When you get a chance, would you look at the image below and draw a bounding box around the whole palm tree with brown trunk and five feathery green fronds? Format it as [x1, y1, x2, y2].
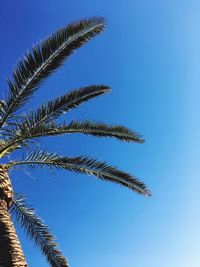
[0, 17, 150, 267]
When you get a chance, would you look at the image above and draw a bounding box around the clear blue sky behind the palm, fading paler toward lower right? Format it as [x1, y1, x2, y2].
[0, 0, 200, 267]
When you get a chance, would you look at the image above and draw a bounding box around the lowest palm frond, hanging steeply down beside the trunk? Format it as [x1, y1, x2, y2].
[11, 194, 69, 267]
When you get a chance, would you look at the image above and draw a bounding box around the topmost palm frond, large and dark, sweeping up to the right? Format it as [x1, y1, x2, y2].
[0, 17, 105, 128]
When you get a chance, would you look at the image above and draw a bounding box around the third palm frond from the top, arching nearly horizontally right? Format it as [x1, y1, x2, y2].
[0, 113, 144, 158]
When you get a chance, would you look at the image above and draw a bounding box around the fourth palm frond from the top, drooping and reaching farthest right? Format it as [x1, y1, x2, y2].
[7, 151, 151, 196]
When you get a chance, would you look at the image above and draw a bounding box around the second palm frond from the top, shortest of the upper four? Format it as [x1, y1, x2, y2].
[0, 85, 110, 158]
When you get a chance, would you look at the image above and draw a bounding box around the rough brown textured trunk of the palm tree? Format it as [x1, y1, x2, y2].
[0, 165, 28, 267]
